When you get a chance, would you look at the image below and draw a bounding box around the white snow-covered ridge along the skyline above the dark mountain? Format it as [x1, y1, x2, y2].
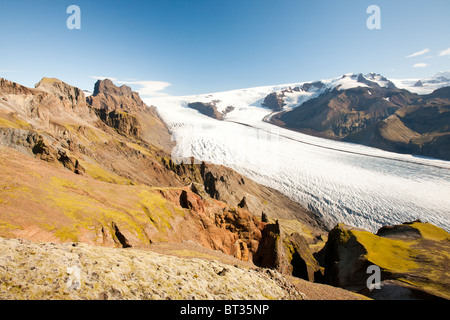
[147, 71, 450, 119]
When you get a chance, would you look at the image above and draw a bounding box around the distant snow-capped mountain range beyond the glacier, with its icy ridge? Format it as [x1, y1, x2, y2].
[180, 72, 450, 160]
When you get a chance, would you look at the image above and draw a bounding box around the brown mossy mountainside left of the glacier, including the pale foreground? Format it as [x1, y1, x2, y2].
[0, 78, 447, 299]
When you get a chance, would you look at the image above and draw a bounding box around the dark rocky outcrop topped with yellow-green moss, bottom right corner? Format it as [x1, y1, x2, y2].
[322, 221, 450, 299]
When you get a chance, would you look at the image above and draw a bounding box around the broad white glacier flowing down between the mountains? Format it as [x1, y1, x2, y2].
[144, 75, 450, 232]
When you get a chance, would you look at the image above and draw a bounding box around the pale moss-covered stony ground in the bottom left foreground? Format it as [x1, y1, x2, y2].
[0, 238, 304, 300]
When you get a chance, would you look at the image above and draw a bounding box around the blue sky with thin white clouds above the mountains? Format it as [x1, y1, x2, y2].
[0, 0, 450, 96]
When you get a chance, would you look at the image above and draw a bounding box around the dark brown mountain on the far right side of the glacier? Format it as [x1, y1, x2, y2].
[270, 74, 450, 160]
